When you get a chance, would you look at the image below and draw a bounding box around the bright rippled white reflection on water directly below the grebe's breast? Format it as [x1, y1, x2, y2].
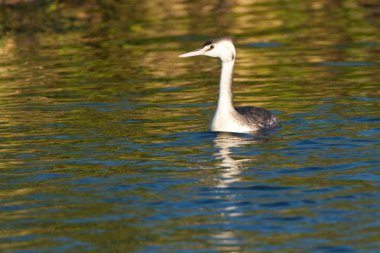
[214, 133, 259, 188]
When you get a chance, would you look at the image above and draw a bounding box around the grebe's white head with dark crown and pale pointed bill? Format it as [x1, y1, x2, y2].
[179, 38, 236, 62]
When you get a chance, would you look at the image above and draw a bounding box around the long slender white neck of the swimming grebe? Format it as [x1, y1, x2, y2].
[216, 60, 235, 114]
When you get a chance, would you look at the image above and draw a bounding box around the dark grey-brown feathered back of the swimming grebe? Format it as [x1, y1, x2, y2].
[235, 106, 280, 129]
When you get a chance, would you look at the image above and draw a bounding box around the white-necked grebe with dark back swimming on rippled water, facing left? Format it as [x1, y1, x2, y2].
[179, 37, 280, 133]
